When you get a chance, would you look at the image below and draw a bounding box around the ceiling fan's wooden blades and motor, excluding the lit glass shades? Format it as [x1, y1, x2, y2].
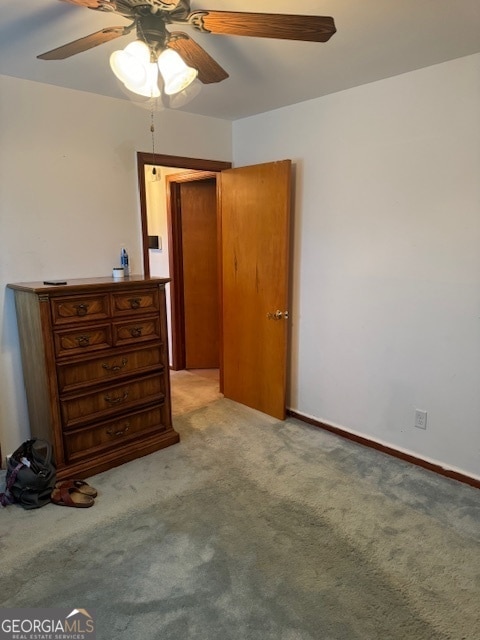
[37, 0, 336, 95]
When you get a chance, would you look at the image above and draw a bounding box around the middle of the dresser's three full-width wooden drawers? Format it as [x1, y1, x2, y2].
[60, 373, 165, 428]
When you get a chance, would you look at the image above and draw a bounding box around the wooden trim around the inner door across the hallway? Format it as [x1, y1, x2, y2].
[165, 171, 221, 371]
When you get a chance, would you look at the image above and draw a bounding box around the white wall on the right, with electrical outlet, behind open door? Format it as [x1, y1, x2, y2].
[233, 55, 480, 478]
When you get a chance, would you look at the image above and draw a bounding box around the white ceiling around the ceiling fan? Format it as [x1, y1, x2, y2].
[0, 0, 480, 120]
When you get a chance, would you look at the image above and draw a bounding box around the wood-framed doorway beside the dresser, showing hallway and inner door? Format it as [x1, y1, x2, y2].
[137, 152, 231, 379]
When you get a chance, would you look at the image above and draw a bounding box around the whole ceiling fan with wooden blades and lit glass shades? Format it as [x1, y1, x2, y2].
[37, 0, 336, 108]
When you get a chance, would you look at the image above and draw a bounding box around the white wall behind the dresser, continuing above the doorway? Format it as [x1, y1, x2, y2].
[0, 76, 232, 455]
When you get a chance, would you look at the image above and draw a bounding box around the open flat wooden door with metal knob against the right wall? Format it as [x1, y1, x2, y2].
[219, 160, 291, 420]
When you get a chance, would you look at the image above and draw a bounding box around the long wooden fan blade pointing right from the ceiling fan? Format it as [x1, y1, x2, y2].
[188, 10, 336, 42]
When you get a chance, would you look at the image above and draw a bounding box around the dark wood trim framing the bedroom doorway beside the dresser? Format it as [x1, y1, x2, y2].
[137, 151, 232, 278]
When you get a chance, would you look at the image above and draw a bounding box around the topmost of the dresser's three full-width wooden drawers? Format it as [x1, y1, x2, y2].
[57, 344, 164, 393]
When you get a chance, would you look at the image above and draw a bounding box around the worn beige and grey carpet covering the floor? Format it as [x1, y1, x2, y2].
[0, 372, 480, 640]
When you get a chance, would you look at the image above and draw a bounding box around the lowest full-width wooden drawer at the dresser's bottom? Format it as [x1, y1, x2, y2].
[64, 406, 166, 462]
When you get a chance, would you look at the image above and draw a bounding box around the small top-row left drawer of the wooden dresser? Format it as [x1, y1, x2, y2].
[50, 294, 110, 325]
